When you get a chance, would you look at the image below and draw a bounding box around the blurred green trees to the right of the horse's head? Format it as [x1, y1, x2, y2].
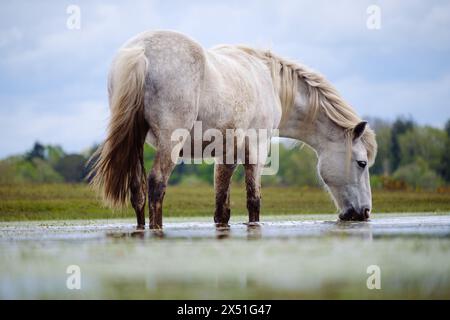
[371, 118, 450, 189]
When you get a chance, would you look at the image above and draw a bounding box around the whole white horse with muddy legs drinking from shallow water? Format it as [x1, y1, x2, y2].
[88, 31, 377, 229]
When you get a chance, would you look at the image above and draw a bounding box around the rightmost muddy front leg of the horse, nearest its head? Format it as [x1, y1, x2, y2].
[244, 164, 261, 223]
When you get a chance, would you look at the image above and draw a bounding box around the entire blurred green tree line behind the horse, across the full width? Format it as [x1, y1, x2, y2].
[0, 117, 450, 190]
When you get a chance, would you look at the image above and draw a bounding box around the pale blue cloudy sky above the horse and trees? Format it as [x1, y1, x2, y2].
[0, 0, 450, 157]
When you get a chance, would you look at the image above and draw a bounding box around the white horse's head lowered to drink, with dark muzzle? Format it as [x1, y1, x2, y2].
[318, 121, 372, 221]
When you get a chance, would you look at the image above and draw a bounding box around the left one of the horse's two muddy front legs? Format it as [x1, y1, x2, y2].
[214, 164, 236, 227]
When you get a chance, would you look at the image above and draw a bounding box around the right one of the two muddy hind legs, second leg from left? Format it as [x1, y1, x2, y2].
[148, 150, 175, 229]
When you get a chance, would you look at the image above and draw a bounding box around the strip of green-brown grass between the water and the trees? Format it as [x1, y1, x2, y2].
[0, 184, 450, 221]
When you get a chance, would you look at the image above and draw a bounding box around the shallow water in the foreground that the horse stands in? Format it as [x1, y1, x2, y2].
[0, 214, 450, 299]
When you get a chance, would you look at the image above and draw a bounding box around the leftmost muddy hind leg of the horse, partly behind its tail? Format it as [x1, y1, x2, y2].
[130, 164, 146, 229]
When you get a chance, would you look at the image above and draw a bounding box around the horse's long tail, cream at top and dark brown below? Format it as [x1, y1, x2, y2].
[89, 46, 149, 207]
